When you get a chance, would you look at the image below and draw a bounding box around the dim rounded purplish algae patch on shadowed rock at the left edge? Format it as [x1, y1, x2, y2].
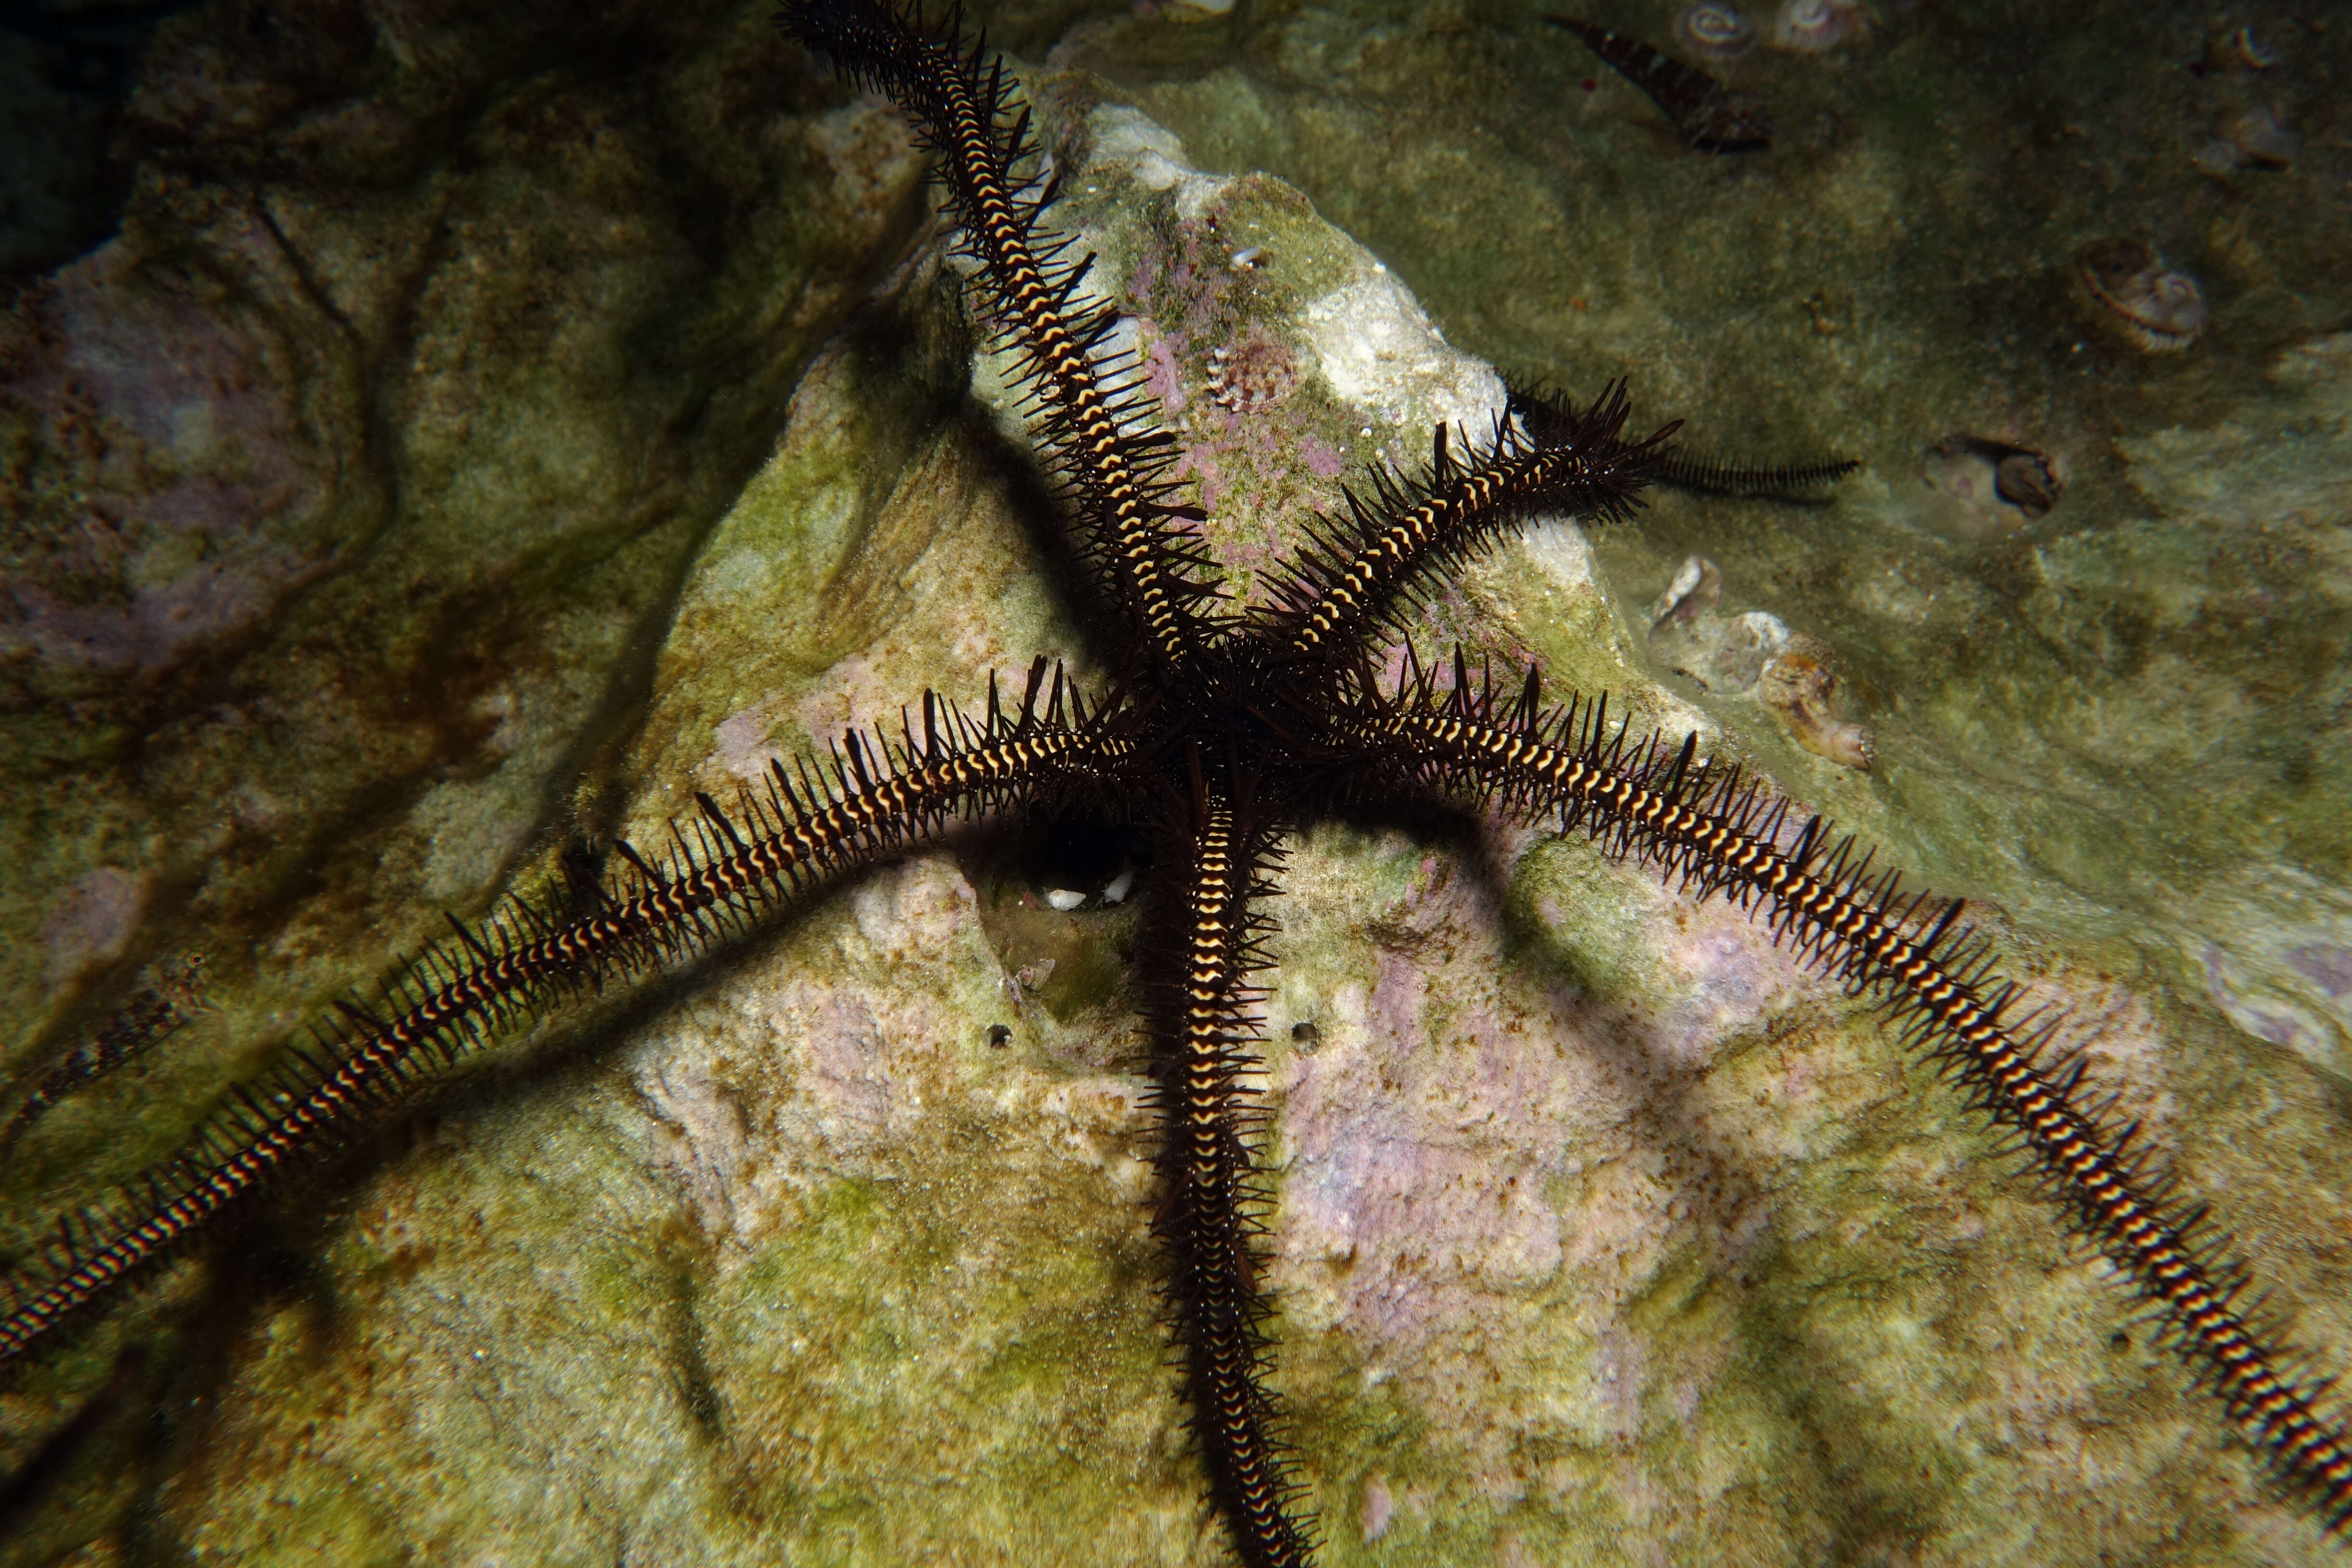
[0, 240, 322, 672]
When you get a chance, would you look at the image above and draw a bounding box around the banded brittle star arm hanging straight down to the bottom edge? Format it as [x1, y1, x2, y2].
[1152, 766, 1312, 1568]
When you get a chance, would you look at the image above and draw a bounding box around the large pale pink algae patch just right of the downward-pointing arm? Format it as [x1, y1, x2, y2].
[1277, 835, 1806, 1488]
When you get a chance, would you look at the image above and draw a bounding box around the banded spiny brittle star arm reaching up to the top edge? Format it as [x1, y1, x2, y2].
[779, 0, 1216, 672]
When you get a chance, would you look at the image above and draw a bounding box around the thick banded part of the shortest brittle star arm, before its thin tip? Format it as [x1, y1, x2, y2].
[1263, 386, 1673, 667]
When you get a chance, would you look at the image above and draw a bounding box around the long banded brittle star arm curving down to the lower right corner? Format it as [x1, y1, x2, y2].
[1341, 653, 2352, 1528]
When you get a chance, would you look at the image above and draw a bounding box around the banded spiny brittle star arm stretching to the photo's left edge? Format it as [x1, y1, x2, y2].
[0, 658, 1129, 1363]
